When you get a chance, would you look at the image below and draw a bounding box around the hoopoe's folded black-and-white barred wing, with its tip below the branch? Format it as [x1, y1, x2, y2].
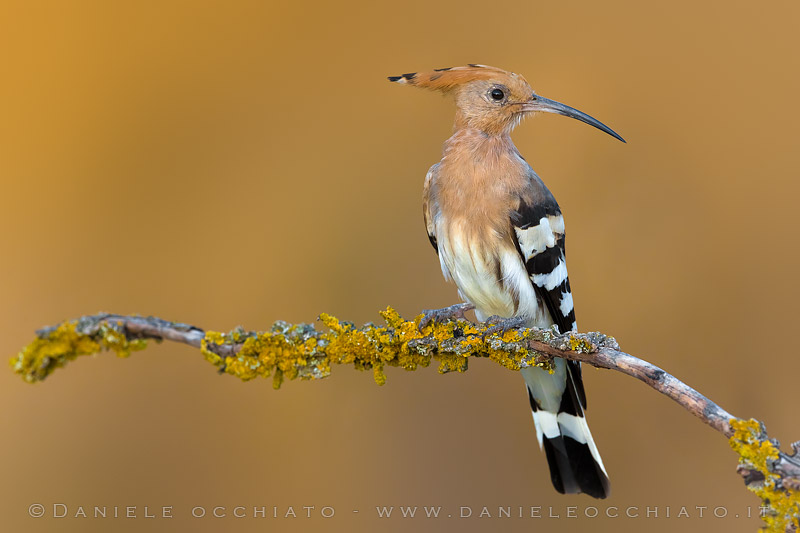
[511, 193, 586, 408]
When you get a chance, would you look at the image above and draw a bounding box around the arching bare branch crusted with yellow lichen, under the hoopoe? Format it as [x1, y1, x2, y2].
[11, 308, 800, 532]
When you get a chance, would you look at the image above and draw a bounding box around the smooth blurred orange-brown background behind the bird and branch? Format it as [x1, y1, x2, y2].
[0, 0, 800, 532]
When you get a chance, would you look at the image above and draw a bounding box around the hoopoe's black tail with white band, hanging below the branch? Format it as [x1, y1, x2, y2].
[522, 359, 610, 498]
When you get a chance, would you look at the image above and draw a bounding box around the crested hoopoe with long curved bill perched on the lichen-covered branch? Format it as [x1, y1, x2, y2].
[388, 64, 625, 498]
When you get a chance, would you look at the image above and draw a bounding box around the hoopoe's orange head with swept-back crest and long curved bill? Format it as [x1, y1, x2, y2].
[389, 64, 625, 142]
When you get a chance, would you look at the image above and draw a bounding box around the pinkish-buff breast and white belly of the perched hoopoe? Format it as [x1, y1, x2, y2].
[425, 131, 546, 325]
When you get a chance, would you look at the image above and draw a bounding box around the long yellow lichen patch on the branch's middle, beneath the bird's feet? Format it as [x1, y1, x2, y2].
[192, 307, 549, 388]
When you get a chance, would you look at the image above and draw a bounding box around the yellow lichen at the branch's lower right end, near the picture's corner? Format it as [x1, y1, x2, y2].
[730, 418, 800, 533]
